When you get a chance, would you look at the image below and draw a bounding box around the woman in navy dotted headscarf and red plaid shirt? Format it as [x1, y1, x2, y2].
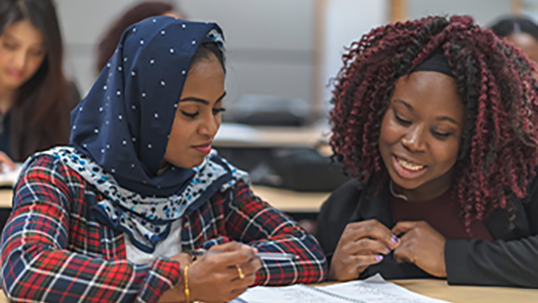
[2, 17, 326, 302]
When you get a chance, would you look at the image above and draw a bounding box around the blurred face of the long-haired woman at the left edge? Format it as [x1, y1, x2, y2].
[0, 19, 46, 89]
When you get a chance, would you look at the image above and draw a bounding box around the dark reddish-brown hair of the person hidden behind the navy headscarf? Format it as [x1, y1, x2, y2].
[95, 1, 176, 74]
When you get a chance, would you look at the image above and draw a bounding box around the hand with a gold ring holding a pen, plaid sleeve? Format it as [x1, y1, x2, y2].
[188, 242, 262, 302]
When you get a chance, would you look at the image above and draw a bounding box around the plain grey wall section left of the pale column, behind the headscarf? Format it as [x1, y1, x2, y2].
[56, 0, 314, 112]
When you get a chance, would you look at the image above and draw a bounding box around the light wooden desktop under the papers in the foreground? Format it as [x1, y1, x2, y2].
[0, 279, 538, 303]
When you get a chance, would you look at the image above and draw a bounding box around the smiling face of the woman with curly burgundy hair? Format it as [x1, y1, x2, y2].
[379, 71, 465, 201]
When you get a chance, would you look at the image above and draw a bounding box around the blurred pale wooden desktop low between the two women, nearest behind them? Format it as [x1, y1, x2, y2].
[251, 185, 324, 213]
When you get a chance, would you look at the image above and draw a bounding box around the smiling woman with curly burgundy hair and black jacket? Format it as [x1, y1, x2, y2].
[317, 16, 538, 288]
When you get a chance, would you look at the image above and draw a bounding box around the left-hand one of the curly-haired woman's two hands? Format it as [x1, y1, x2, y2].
[329, 220, 399, 281]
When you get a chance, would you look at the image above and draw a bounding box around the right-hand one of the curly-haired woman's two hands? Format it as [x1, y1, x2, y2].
[392, 221, 446, 278]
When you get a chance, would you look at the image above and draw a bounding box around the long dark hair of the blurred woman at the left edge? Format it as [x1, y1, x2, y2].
[0, 0, 70, 161]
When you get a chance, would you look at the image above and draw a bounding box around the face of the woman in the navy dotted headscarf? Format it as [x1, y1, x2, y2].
[164, 54, 226, 168]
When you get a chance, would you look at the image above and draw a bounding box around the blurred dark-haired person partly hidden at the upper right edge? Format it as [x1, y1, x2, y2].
[490, 16, 538, 63]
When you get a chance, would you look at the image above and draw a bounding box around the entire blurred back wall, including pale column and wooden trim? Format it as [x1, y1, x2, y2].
[56, 0, 538, 116]
